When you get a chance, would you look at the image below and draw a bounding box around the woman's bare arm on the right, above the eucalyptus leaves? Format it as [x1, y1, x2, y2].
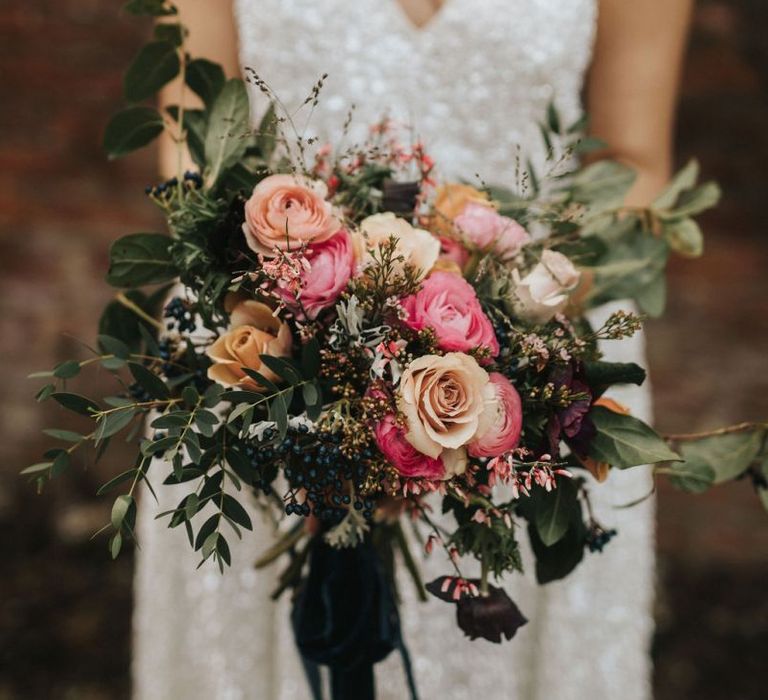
[587, 0, 693, 206]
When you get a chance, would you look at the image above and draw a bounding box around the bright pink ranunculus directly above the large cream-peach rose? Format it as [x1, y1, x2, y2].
[402, 272, 499, 357]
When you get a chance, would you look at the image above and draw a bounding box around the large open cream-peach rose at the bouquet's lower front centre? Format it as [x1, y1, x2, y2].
[398, 352, 493, 475]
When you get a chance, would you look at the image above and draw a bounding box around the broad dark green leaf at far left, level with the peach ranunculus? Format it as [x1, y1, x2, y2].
[107, 233, 176, 287]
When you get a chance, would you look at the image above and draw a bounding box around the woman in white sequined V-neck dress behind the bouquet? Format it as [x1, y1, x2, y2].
[133, 0, 691, 700]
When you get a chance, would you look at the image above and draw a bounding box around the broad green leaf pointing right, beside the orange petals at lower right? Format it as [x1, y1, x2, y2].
[588, 406, 681, 469]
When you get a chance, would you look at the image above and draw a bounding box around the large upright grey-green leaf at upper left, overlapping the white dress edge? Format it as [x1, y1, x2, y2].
[205, 79, 248, 183]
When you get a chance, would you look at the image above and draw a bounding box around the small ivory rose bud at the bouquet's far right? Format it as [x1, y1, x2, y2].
[512, 250, 581, 323]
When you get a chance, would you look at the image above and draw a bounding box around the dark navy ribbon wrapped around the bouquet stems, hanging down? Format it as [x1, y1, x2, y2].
[292, 537, 418, 700]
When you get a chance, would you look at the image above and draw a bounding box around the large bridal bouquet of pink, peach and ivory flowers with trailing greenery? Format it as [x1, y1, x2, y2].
[24, 2, 766, 696]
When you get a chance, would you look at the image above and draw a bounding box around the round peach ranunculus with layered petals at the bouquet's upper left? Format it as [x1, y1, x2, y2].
[243, 175, 341, 257]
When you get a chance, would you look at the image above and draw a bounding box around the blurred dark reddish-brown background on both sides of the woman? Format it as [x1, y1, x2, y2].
[0, 0, 768, 700]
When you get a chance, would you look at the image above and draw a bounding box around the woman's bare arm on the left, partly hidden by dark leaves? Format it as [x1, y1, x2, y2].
[158, 0, 240, 177]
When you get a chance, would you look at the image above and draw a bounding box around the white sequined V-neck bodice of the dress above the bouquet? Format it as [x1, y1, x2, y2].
[236, 0, 597, 185]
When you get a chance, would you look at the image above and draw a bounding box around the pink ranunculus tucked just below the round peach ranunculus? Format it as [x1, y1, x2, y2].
[278, 229, 356, 319]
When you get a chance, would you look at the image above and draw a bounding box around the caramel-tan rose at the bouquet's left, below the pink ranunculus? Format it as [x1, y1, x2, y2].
[206, 300, 293, 391]
